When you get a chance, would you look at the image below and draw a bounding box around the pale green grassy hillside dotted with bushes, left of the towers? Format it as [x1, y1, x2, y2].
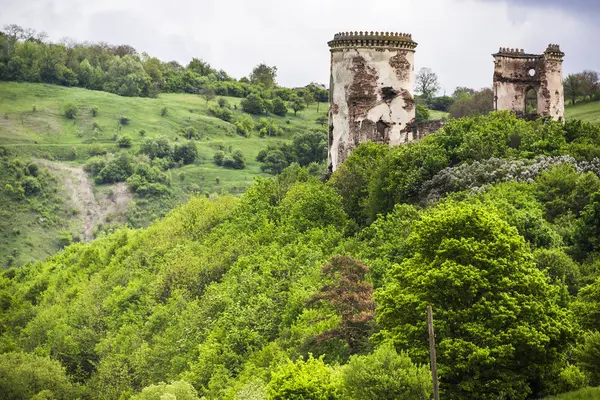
[0, 82, 327, 264]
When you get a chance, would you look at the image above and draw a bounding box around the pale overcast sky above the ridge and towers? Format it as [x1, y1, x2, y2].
[0, 0, 600, 94]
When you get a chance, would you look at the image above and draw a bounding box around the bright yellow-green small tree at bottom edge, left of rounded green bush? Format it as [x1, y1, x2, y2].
[267, 355, 341, 400]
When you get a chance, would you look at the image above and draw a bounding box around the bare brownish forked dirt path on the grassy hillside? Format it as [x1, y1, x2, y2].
[35, 159, 132, 242]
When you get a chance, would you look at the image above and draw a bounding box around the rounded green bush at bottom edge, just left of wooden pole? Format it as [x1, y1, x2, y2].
[342, 343, 433, 400]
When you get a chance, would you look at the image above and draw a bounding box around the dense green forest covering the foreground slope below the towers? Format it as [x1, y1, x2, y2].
[0, 112, 600, 399]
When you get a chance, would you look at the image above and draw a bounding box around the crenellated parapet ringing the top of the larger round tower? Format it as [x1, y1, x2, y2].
[328, 31, 417, 51]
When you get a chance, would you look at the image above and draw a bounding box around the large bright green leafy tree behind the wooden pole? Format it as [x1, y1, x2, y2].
[376, 202, 573, 399]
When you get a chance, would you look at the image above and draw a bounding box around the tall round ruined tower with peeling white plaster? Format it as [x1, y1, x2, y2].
[328, 32, 417, 172]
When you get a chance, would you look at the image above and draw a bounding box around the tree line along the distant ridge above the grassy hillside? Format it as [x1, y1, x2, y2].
[0, 24, 327, 108]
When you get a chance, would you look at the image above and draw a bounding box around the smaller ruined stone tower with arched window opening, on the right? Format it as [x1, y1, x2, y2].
[493, 44, 565, 120]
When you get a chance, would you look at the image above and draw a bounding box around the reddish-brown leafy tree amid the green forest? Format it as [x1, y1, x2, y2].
[309, 256, 375, 354]
